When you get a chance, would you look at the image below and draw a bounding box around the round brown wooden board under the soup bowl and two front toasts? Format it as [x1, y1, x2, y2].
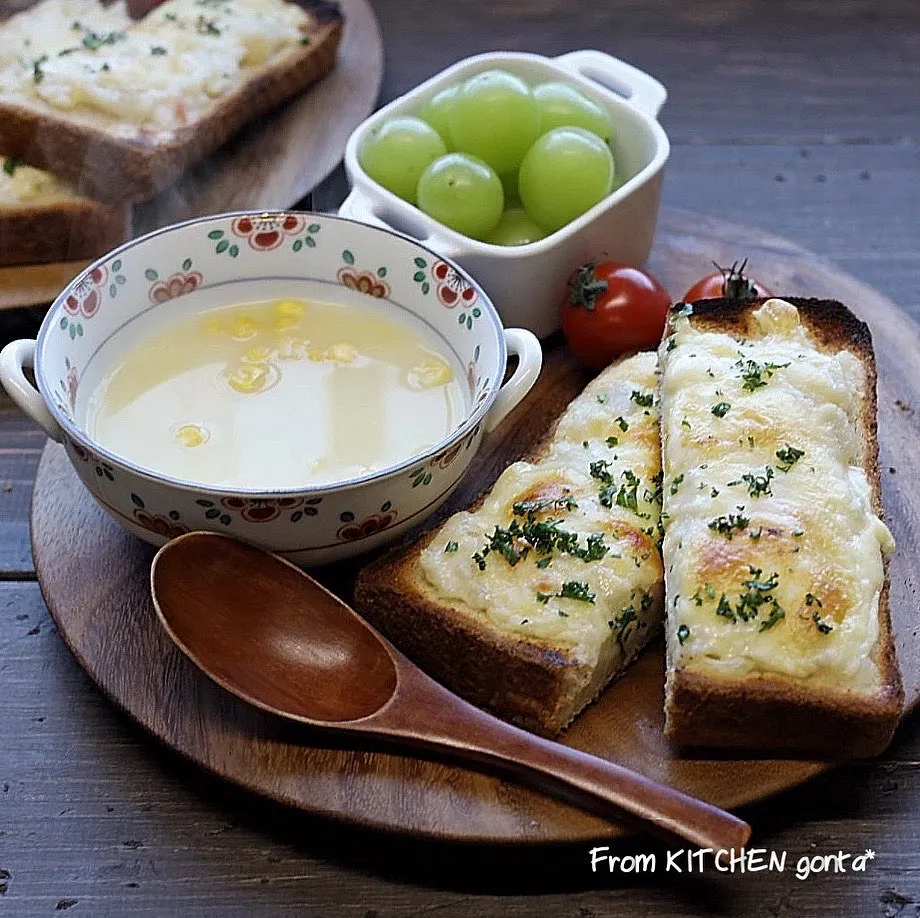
[32, 211, 920, 842]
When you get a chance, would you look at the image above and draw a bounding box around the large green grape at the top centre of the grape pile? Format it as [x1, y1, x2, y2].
[448, 70, 540, 175]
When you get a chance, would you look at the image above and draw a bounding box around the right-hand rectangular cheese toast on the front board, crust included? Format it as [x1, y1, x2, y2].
[660, 298, 903, 757]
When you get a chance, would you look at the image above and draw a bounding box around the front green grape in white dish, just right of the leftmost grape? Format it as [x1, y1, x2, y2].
[418, 153, 505, 239]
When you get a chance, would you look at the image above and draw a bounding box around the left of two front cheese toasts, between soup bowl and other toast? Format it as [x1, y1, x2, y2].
[355, 353, 662, 736]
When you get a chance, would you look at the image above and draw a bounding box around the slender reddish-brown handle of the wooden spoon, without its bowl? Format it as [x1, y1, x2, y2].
[363, 655, 751, 851]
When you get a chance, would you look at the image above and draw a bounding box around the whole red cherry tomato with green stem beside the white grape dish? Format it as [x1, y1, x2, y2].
[562, 261, 671, 370]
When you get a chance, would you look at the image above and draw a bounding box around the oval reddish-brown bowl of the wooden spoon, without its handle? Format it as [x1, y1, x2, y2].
[151, 532, 397, 724]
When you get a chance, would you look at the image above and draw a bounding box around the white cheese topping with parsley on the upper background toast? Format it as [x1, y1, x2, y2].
[0, 0, 312, 139]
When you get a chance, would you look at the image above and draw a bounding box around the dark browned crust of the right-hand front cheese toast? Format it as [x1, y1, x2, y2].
[665, 297, 904, 758]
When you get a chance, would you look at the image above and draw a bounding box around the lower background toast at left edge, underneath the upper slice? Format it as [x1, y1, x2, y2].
[0, 156, 131, 267]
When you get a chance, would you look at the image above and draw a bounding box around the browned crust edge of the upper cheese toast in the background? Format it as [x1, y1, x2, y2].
[0, 0, 343, 201]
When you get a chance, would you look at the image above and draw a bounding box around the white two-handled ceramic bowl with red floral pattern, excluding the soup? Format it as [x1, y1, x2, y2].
[0, 212, 541, 565]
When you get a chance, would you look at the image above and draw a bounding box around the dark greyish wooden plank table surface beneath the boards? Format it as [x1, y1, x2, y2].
[0, 0, 920, 918]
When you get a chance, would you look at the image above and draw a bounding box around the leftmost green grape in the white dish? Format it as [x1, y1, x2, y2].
[358, 117, 447, 204]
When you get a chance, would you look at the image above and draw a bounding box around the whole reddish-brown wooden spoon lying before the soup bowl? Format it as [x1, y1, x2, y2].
[150, 532, 751, 850]
